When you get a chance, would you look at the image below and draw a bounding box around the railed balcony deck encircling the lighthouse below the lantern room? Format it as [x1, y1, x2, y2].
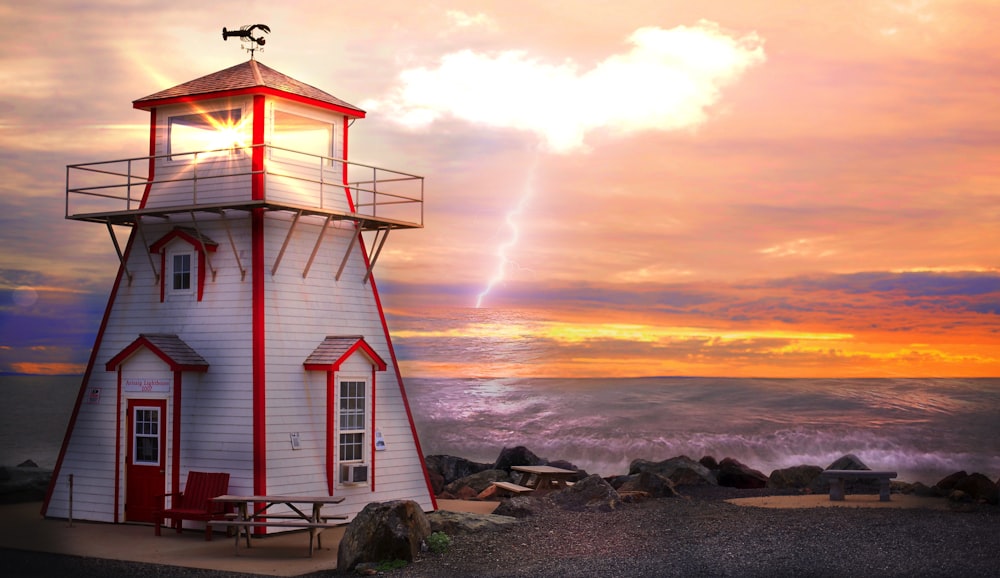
[65, 145, 424, 229]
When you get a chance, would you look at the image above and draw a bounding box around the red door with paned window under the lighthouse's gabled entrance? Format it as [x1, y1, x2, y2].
[125, 399, 167, 522]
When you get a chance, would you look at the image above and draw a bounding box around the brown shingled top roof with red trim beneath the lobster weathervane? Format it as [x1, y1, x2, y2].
[132, 60, 365, 117]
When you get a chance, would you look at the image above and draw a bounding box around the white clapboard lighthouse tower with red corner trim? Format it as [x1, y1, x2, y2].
[43, 58, 436, 522]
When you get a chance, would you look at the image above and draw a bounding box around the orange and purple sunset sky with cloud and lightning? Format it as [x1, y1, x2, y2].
[0, 0, 1000, 378]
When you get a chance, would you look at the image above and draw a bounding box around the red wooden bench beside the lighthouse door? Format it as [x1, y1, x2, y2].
[153, 472, 230, 540]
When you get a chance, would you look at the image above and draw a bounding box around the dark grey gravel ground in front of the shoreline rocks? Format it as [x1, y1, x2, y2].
[0, 490, 1000, 578]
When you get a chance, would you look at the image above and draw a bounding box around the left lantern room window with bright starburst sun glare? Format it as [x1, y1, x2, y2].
[167, 108, 250, 160]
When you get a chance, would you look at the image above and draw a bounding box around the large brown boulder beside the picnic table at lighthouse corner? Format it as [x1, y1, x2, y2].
[337, 500, 431, 572]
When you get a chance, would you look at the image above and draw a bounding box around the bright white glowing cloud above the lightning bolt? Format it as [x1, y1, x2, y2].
[362, 20, 765, 153]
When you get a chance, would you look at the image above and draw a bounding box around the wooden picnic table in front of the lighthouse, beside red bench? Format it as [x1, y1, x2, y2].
[209, 494, 347, 556]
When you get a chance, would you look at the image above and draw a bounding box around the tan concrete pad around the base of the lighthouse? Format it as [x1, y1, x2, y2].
[0, 500, 497, 576]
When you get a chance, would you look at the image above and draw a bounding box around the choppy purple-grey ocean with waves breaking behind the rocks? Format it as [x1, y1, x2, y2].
[0, 376, 1000, 485]
